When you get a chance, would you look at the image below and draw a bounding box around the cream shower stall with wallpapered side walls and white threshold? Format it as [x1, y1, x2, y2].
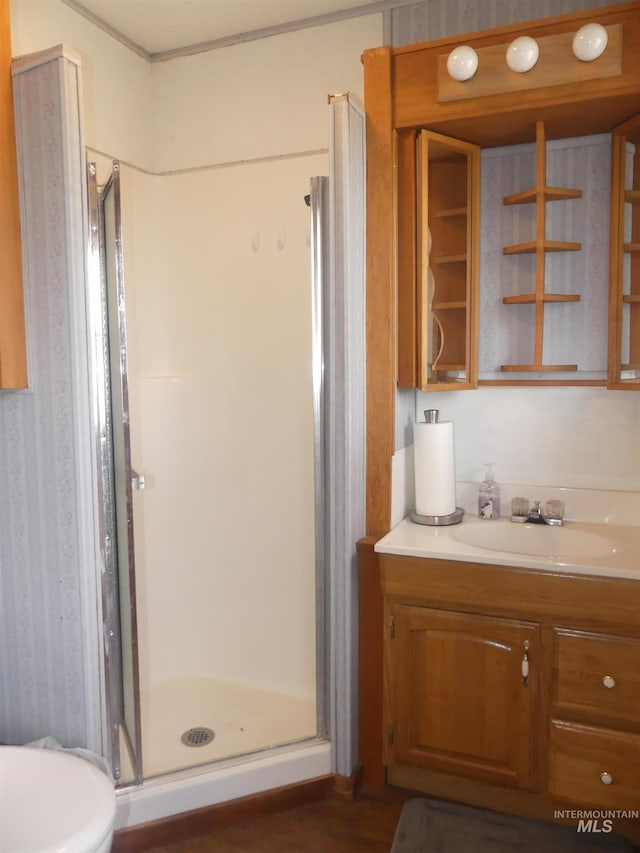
[0, 45, 365, 827]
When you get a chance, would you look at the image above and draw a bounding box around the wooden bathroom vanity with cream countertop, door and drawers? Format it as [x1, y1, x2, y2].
[375, 518, 640, 843]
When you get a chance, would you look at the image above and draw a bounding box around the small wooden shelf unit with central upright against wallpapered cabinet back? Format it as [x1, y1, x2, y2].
[500, 121, 582, 373]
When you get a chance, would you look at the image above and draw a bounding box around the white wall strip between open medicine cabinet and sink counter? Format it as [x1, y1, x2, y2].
[416, 386, 640, 491]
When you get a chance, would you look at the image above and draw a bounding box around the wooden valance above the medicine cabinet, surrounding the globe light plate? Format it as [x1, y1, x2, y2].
[392, 0, 640, 147]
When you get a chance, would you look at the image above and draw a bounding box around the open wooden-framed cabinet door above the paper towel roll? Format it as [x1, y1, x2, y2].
[416, 130, 480, 391]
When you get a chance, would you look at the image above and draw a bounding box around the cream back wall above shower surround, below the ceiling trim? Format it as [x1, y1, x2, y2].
[153, 15, 382, 171]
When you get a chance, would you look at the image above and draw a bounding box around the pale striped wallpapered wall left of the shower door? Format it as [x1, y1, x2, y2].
[0, 49, 100, 749]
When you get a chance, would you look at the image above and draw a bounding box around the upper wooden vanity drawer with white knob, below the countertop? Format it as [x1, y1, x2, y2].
[553, 628, 640, 728]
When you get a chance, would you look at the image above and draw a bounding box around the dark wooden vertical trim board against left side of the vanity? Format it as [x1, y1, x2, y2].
[357, 536, 385, 785]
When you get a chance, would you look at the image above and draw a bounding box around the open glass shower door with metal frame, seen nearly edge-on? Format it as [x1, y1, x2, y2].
[88, 161, 144, 783]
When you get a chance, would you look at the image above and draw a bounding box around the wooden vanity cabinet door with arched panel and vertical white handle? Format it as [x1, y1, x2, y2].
[386, 604, 540, 789]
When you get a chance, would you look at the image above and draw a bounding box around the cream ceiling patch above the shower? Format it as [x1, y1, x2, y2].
[63, 0, 388, 56]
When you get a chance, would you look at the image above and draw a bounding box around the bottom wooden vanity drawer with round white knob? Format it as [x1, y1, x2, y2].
[549, 720, 640, 809]
